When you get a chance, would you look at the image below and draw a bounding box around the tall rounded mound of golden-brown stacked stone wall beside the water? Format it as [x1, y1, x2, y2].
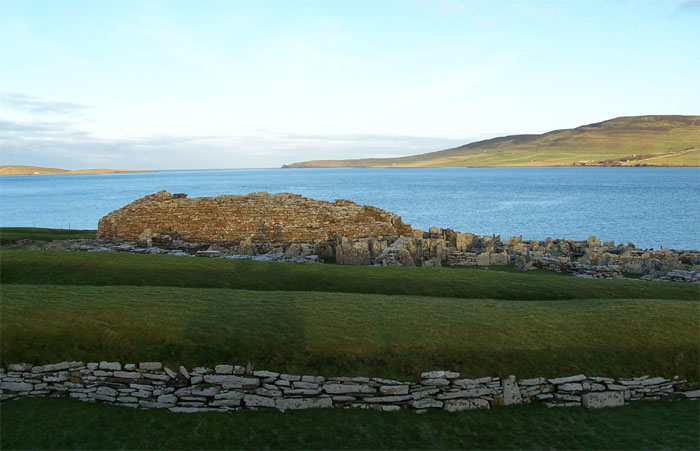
[97, 191, 413, 252]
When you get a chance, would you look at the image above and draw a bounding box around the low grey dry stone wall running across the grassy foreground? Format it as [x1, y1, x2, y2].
[0, 361, 700, 413]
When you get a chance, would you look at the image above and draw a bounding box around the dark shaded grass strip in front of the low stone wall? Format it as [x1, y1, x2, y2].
[0, 398, 700, 449]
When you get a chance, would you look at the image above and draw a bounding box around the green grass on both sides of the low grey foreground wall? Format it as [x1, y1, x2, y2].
[0, 230, 700, 449]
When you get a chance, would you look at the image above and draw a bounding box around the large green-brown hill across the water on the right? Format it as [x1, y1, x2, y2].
[283, 116, 700, 168]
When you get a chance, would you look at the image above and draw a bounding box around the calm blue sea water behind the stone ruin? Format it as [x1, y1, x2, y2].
[0, 168, 700, 249]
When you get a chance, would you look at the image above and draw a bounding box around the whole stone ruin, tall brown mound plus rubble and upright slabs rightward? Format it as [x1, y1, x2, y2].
[90, 191, 700, 282]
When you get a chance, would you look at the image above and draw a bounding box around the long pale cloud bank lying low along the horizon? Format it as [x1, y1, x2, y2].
[0, 120, 466, 169]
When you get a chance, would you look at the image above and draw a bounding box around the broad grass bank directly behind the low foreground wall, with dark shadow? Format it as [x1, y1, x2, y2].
[0, 285, 700, 380]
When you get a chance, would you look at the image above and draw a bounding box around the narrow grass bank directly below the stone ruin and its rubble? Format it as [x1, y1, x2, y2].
[0, 249, 700, 301]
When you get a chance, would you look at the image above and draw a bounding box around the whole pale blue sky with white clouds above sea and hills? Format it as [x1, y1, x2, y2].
[0, 0, 700, 169]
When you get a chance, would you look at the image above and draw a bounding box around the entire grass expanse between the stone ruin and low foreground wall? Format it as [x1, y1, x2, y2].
[0, 250, 700, 379]
